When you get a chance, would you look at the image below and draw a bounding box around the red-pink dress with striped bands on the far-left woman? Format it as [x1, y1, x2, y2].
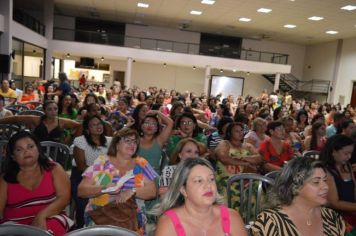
[0, 171, 73, 236]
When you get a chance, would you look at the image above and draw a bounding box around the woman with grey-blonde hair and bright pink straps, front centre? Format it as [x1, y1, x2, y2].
[152, 158, 247, 236]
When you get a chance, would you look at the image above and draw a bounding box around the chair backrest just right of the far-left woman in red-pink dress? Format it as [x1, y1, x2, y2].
[41, 141, 71, 170]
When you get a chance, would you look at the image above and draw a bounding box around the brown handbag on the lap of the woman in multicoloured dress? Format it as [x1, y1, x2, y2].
[88, 196, 138, 231]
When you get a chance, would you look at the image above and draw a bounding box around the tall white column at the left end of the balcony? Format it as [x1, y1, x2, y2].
[42, 0, 54, 80]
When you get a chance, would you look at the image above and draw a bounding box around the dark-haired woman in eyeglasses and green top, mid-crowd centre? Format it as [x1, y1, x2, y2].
[167, 112, 208, 157]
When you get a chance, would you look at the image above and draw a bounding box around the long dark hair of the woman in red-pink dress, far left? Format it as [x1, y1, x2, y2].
[4, 131, 55, 183]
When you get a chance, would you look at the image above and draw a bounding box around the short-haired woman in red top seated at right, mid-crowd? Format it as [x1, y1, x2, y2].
[259, 121, 293, 172]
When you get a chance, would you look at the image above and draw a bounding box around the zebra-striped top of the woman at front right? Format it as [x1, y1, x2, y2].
[252, 207, 345, 236]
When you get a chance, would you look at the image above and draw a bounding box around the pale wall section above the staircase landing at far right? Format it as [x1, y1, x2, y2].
[303, 41, 337, 81]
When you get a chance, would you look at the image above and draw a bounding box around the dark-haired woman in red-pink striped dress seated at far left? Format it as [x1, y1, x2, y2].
[0, 131, 73, 236]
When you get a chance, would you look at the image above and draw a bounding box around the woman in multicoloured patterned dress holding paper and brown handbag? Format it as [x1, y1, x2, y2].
[78, 128, 158, 235]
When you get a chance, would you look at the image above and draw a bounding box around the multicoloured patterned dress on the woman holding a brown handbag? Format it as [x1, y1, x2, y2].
[83, 155, 158, 234]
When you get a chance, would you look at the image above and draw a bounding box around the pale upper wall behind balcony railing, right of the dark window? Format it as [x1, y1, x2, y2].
[242, 39, 305, 80]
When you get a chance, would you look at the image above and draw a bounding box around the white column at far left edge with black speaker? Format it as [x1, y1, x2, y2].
[0, 0, 13, 79]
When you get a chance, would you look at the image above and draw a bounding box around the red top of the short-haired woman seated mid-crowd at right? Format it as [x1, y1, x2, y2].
[259, 139, 293, 167]
